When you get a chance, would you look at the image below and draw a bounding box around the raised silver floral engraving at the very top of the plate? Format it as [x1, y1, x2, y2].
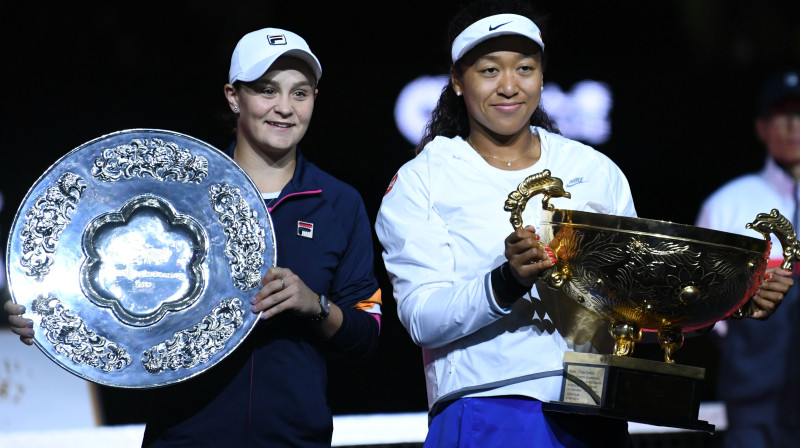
[92, 138, 208, 184]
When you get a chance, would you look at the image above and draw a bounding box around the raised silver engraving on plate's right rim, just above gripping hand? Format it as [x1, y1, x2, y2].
[211, 184, 266, 291]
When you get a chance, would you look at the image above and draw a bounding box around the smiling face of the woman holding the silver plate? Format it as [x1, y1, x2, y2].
[225, 57, 317, 158]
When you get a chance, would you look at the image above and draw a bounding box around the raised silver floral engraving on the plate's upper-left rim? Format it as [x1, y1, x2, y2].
[20, 172, 86, 280]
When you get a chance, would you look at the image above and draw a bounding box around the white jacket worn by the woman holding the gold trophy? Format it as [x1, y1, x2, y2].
[375, 128, 636, 406]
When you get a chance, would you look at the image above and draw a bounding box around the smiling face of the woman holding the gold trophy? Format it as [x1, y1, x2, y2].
[451, 35, 544, 140]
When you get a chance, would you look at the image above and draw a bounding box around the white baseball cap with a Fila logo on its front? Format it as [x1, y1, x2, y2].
[228, 28, 322, 84]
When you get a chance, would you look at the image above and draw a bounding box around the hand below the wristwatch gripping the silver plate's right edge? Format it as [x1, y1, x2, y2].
[252, 267, 320, 319]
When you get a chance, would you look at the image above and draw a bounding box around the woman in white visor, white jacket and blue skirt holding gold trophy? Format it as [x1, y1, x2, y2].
[375, 2, 636, 448]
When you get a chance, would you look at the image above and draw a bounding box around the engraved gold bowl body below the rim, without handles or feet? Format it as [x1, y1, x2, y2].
[550, 226, 764, 329]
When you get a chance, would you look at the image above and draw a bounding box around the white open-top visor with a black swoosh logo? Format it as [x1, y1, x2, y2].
[452, 14, 544, 63]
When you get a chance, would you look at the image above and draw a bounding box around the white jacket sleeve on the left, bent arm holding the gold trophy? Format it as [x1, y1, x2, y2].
[375, 158, 509, 348]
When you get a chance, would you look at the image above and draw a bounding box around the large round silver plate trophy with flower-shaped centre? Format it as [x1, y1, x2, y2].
[7, 129, 276, 388]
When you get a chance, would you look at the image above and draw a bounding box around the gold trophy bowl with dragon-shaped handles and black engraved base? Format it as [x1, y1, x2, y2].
[504, 170, 800, 431]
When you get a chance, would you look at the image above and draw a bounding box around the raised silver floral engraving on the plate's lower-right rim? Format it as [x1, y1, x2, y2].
[142, 298, 244, 375]
